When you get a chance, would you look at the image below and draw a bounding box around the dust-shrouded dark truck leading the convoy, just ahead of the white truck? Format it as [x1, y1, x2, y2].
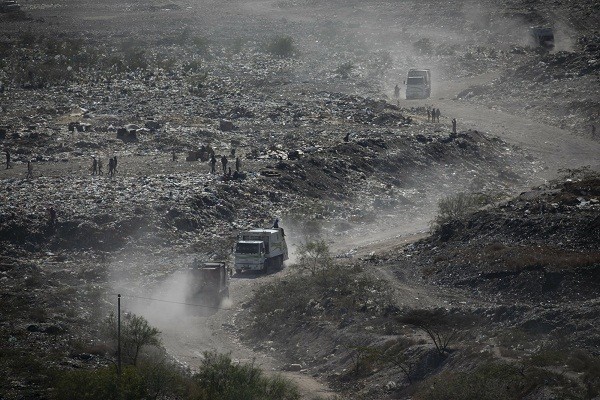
[188, 261, 230, 307]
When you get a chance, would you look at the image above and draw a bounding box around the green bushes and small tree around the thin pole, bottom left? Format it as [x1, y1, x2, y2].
[50, 315, 300, 400]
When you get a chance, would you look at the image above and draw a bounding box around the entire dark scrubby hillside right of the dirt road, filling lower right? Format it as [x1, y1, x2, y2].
[243, 170, 600, 399]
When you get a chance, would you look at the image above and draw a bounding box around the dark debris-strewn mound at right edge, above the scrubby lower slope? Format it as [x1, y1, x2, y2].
[414, 170, 600, 304]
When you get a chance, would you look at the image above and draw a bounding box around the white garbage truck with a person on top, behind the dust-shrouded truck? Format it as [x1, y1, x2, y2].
[234, 228, 288, 274]
